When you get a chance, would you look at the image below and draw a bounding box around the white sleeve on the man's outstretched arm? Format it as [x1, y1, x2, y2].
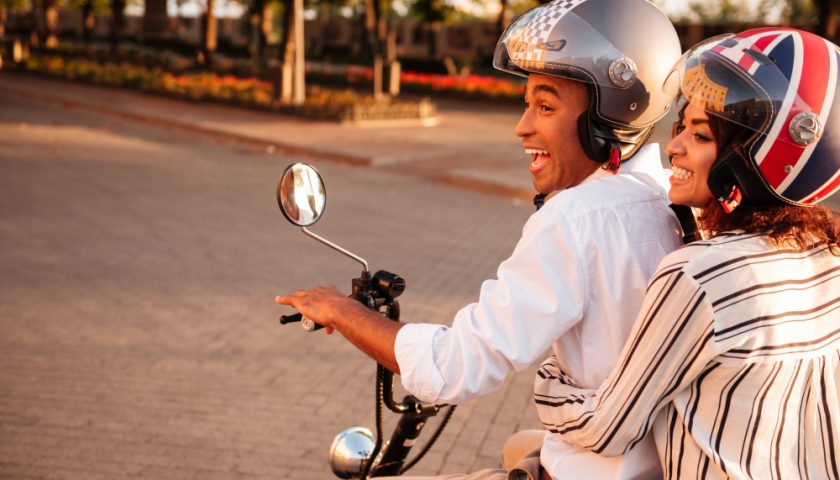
[395, 209, 587, 403]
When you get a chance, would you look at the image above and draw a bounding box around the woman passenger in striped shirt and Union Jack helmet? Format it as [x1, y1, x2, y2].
[535, 28, 840, 479]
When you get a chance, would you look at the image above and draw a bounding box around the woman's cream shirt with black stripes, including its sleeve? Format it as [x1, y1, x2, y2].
[534, 234, 840, 479]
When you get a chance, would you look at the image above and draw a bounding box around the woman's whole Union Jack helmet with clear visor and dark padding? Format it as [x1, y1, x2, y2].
[665, 27, 840, 211]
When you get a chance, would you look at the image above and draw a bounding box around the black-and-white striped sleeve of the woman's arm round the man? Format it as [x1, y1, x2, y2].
[534, 257, 717, 455]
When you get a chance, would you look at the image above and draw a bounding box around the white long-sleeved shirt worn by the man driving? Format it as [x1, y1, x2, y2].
[395, 144, 681, 480]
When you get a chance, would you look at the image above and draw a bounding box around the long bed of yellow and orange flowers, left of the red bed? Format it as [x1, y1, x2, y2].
[18, 55, 436, 121]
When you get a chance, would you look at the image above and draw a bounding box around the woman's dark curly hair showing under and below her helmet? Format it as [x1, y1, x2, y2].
[679, 102, 840, 256]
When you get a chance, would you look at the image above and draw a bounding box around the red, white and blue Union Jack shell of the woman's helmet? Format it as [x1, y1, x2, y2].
[709, 28, 840, 204]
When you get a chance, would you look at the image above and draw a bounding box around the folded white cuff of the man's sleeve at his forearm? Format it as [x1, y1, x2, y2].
[394, 323, 446, 402]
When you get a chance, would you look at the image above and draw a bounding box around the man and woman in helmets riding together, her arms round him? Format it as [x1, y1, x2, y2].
[277, 0, 840, 480]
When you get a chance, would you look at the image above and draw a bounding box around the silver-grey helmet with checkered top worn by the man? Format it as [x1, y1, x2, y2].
[493, 0, 681, 162]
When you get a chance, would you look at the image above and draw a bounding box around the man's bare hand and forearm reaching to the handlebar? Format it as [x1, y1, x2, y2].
[274, 286, 402, 373]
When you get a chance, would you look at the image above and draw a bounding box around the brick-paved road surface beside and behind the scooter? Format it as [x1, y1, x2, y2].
[0, 92, 537, 479]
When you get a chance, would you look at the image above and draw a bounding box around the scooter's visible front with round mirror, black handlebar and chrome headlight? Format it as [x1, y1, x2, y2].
[277, 163, 455, 480]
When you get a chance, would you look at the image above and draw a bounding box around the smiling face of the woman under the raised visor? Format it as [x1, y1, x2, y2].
[665, 104, 718, 208]
